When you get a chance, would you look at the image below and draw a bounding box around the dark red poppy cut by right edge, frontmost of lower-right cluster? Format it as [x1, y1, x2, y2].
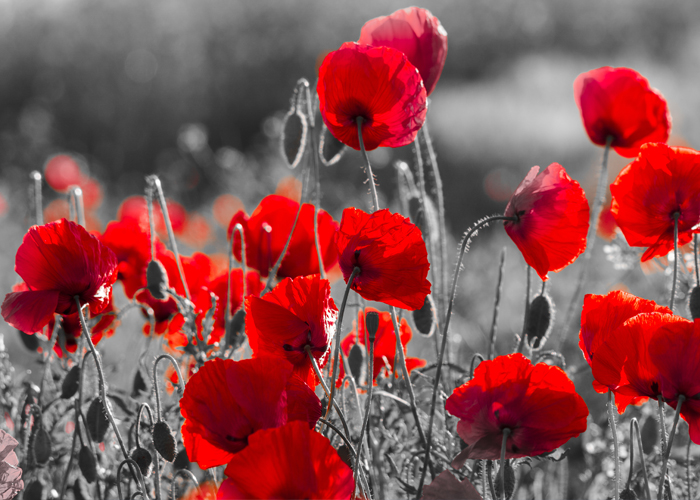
[649, 319, 700, 444]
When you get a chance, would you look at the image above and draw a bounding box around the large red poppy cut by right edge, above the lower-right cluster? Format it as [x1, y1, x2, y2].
[610, 143, 700, 262]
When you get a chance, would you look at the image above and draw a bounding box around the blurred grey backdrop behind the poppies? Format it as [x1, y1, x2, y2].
[0, 0, 700, 428]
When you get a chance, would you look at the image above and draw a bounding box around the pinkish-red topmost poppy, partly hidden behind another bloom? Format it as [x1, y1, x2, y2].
[357, 7, 447, 95]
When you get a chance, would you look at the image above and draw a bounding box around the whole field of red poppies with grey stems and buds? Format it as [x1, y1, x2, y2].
[0, 3, 700, 500]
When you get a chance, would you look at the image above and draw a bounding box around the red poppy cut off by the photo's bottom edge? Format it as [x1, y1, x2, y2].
[217, 422, 355, 500]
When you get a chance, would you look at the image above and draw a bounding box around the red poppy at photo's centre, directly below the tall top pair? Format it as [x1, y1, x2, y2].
[335, 207, 430, 311]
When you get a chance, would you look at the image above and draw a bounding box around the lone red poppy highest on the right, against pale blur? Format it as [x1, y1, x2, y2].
[574, 66, 671, 158]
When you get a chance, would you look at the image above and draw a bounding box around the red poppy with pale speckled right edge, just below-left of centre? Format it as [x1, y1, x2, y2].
[245, 274, 338, 387]
